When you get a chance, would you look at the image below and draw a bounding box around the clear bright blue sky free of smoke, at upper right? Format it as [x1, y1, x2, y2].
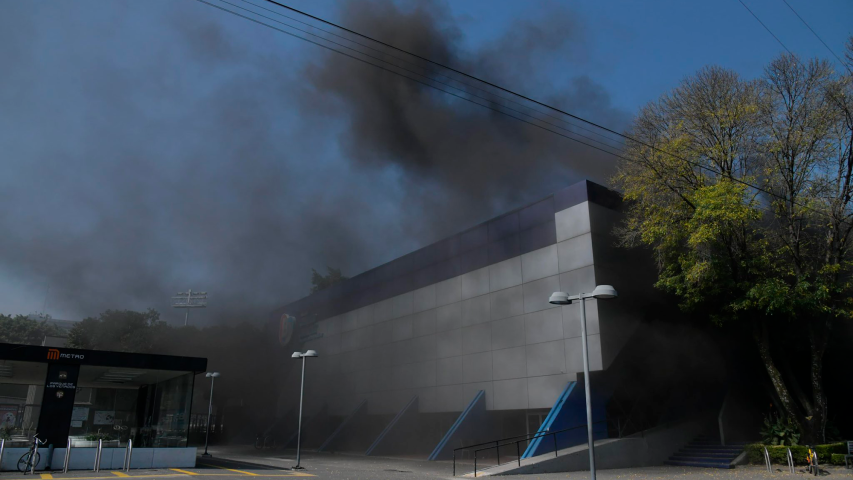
[289, 0, 853, 112]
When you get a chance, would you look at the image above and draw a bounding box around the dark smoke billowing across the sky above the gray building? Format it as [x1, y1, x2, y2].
[0, 0, 627, 322]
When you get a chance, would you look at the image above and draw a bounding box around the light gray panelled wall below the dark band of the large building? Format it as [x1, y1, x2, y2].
[280, 182, 652, 415]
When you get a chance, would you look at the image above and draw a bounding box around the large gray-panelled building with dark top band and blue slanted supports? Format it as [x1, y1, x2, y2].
[271, 182, 728, 459]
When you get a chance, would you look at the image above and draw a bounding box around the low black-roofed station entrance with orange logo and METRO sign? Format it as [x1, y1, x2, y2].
[0, 344, 207, 448]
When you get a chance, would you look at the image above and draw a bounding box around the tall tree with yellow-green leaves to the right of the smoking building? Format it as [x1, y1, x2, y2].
[614, 47, 853, 443]
